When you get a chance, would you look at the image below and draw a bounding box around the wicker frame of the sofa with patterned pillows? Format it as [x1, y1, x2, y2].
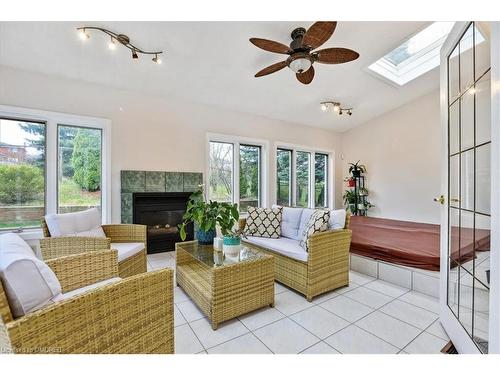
[239, 214, 352, 302]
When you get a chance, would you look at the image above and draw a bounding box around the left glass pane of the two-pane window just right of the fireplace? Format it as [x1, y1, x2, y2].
[208, 142, 233, 202]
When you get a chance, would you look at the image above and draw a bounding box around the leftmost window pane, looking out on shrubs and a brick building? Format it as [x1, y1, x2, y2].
[0, 118, 45, 230]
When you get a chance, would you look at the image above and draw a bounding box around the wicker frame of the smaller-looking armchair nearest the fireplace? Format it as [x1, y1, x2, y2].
[40, 218, 147, 278]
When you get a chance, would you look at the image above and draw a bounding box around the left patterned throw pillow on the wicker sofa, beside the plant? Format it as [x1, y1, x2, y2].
[245, 207, 283, 238]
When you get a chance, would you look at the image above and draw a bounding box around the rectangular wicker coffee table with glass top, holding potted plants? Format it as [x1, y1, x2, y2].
[175, 241, 274, 330]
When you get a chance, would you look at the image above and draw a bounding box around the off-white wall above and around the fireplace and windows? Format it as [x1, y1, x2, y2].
[0, 67, 341, 222]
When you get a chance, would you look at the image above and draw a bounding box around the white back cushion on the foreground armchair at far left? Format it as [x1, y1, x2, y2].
[0, 233, 61, 318]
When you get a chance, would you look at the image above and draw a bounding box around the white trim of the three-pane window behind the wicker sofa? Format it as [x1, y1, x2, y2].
[272, 142, 335, 209]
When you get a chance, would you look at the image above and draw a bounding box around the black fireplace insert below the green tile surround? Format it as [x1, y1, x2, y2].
[132, 193, 194, 253]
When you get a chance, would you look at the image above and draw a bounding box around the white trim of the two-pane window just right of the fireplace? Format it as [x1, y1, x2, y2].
[204, 133, 269, 207]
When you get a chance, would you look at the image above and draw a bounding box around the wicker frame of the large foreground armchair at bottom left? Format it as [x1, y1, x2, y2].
[0, 250, 174, 354]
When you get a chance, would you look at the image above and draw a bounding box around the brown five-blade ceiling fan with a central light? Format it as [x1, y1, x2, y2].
[250, 22, 359, 85]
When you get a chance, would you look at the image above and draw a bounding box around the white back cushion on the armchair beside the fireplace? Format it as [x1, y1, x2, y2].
[45, 208, 105, 237]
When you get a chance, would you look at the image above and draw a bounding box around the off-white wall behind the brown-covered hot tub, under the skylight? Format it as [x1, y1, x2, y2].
[341, 91, 444, 223]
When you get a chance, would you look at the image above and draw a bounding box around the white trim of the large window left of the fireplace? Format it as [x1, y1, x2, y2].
[0, 104, 111, 239]
